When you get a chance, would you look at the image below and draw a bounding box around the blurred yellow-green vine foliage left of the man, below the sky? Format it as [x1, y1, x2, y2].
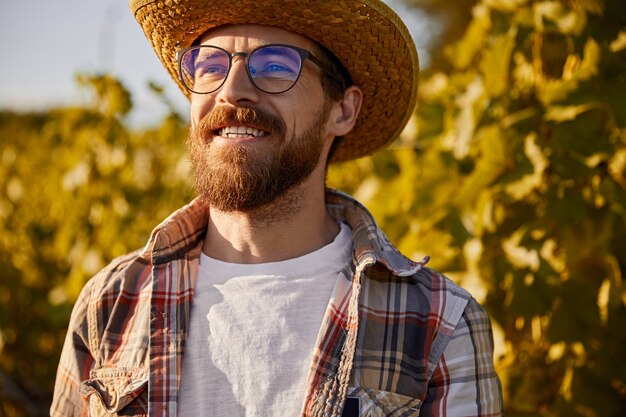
[0, 76, 193, 416]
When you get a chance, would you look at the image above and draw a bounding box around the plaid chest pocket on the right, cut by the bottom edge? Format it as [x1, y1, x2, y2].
[348, 387, 422, 417]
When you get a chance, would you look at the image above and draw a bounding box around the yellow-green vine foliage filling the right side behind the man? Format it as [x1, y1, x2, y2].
[331, 0, 626, 417]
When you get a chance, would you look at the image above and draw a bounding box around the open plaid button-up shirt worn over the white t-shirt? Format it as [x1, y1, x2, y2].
[51, 191, 503, 417]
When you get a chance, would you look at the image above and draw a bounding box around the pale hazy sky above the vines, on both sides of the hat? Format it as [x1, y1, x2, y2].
[0, 0, 436, 126]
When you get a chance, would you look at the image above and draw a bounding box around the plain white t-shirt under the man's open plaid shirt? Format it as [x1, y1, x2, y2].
[178, 224, 352, 417]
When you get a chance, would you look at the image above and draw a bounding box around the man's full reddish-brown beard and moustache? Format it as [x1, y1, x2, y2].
[187, 102, 330, 212]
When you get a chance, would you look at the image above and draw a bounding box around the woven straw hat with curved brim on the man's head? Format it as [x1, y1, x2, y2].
[129, 0, 419, 162]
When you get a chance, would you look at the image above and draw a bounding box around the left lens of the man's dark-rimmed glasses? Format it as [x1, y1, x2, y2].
[181, 46, 230, 93]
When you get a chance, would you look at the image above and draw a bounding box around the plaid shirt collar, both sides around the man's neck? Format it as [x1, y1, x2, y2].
[143, 189, 429, 276]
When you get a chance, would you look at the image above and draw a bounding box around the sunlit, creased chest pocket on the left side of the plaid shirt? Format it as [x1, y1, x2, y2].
[80, 368, 148, 417]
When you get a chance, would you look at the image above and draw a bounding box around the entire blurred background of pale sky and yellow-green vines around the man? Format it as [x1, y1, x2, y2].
[0, 0, 626, 417]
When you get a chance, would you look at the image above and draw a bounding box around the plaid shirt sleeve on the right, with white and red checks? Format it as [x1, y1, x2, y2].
[420, 298, 504, 417]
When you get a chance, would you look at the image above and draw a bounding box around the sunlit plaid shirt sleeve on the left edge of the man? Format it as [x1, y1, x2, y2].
[50, 280, 94, 417]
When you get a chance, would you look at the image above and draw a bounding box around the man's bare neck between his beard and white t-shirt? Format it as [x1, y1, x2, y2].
[202, 172, 339, 264]
